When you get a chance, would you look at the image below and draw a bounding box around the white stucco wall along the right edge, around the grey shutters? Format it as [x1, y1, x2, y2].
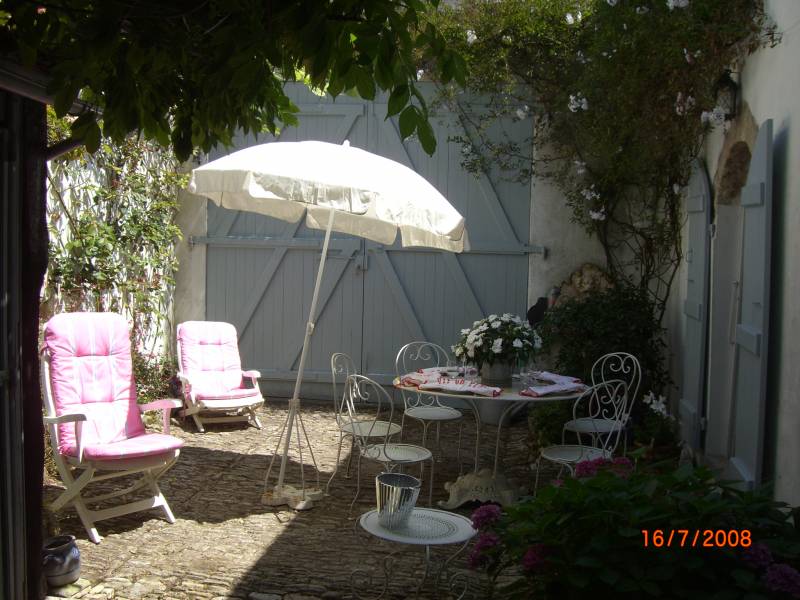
[667, 0, 800, 504]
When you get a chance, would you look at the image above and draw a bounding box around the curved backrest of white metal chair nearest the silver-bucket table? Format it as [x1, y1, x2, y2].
[342, 375, 394, 450]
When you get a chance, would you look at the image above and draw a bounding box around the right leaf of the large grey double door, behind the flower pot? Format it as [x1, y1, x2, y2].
[363, 104, 530, 382]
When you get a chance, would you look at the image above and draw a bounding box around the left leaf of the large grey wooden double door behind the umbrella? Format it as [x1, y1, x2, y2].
[206, 87, 368, 396]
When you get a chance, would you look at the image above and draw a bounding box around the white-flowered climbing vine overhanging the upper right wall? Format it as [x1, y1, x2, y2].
[438, 0, 778, 320]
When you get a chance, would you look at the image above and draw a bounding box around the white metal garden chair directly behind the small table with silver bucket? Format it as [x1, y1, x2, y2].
[343, 375, 433, 509]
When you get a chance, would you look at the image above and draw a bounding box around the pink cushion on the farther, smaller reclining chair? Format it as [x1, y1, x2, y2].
[178, 321, 247, 398]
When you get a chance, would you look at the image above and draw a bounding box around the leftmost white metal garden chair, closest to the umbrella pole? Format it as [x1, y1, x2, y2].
[325, 352, 400, 492]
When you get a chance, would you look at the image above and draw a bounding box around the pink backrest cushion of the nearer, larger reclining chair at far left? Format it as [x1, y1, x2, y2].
[44, 313, 150, 455]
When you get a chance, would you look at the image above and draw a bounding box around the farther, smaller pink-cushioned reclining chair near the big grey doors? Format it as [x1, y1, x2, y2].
[178, 321, 264, 431]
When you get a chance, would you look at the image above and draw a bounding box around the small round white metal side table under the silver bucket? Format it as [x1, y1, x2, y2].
[350, 508, 477, 598]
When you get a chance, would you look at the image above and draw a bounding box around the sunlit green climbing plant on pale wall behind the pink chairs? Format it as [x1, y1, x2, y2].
[43, 110, 186, 355]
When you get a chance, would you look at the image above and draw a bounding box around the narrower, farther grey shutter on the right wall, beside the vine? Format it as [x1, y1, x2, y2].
[680, 161, 711, 448]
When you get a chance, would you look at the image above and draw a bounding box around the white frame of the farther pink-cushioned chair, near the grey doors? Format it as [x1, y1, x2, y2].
[178, 340, 264, 433]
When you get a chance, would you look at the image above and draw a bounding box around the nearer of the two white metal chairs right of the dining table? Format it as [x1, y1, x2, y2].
[533, 380, 627, 494]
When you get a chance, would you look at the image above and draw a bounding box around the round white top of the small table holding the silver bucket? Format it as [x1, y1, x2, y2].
[358, 508, 477, 546]
